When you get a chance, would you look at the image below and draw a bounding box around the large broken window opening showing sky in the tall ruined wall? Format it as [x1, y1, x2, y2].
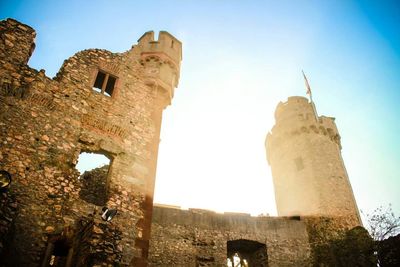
[76, 152, 111, 206]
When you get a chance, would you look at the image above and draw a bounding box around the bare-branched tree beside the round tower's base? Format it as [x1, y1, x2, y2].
[365, 204, 400, 241]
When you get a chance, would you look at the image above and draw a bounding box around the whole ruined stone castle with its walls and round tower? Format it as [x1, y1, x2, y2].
[0, 19, 361, 266]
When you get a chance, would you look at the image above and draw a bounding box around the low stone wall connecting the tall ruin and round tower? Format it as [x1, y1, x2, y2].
[150, 206, 310, 266]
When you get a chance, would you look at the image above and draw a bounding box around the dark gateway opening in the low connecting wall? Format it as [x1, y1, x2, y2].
[227, 239, 268, 267]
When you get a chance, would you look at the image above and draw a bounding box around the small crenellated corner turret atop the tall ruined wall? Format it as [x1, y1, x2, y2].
[137, 31, 182, 104]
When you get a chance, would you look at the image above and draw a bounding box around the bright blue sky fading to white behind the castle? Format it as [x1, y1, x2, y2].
[0, 0, 400, 219]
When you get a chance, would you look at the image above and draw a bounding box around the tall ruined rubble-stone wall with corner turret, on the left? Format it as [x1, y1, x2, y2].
[0, 19, 181, 266]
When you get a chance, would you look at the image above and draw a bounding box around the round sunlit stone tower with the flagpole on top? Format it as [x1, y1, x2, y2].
[265, 96, 361, 223]
